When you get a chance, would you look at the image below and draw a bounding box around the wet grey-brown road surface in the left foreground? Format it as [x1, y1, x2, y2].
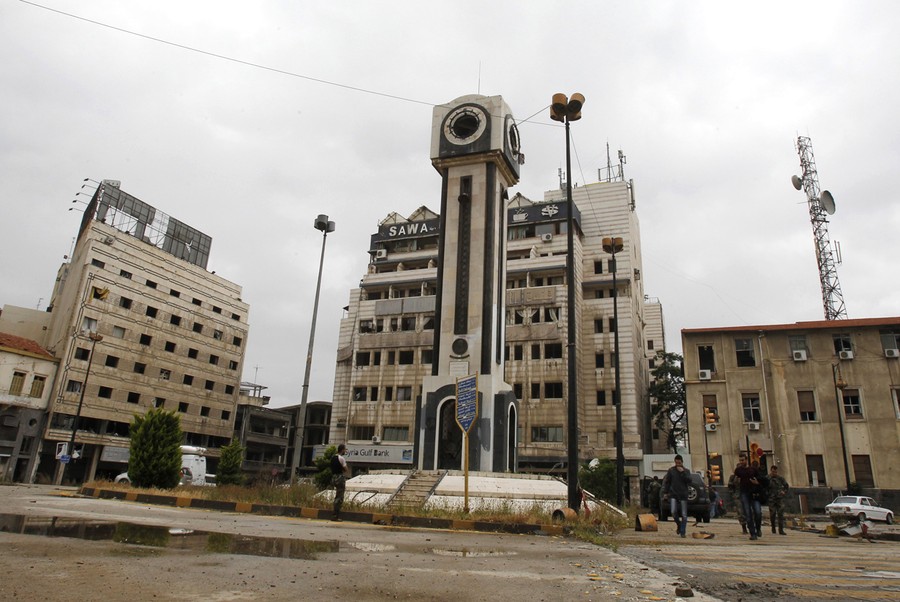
[0, 486, 714, 602]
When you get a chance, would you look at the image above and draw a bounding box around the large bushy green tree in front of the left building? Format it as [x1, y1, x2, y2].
[128, 408, 183, 489]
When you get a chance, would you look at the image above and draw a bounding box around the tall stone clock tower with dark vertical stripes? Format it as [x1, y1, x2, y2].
[416, 94, 524, 472]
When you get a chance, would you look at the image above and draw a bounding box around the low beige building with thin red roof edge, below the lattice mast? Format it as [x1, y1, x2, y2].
[681, 317, 900, 509]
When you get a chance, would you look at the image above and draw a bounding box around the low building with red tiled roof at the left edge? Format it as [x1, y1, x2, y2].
[0, 332, 59, 483]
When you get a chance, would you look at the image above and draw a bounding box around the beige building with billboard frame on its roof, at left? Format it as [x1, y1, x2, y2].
[0, 180, 249, 482]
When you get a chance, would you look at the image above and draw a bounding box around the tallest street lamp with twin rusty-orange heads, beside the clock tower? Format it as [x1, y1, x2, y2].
[550, 93, 584, 512]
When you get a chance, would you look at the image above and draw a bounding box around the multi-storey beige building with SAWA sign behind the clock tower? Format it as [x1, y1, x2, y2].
[330, 181, 664, 487]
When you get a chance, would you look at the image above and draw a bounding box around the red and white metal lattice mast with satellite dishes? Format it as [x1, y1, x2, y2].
[795, 136, 847, 320]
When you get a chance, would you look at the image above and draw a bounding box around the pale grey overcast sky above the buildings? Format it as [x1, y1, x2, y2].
[0, 0, 900, 407]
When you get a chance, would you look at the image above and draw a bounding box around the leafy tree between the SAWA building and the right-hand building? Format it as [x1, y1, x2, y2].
[649, 351, 687, 452]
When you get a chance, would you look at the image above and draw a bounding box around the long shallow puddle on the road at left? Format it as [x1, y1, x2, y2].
[0, 514, 340, 560]
